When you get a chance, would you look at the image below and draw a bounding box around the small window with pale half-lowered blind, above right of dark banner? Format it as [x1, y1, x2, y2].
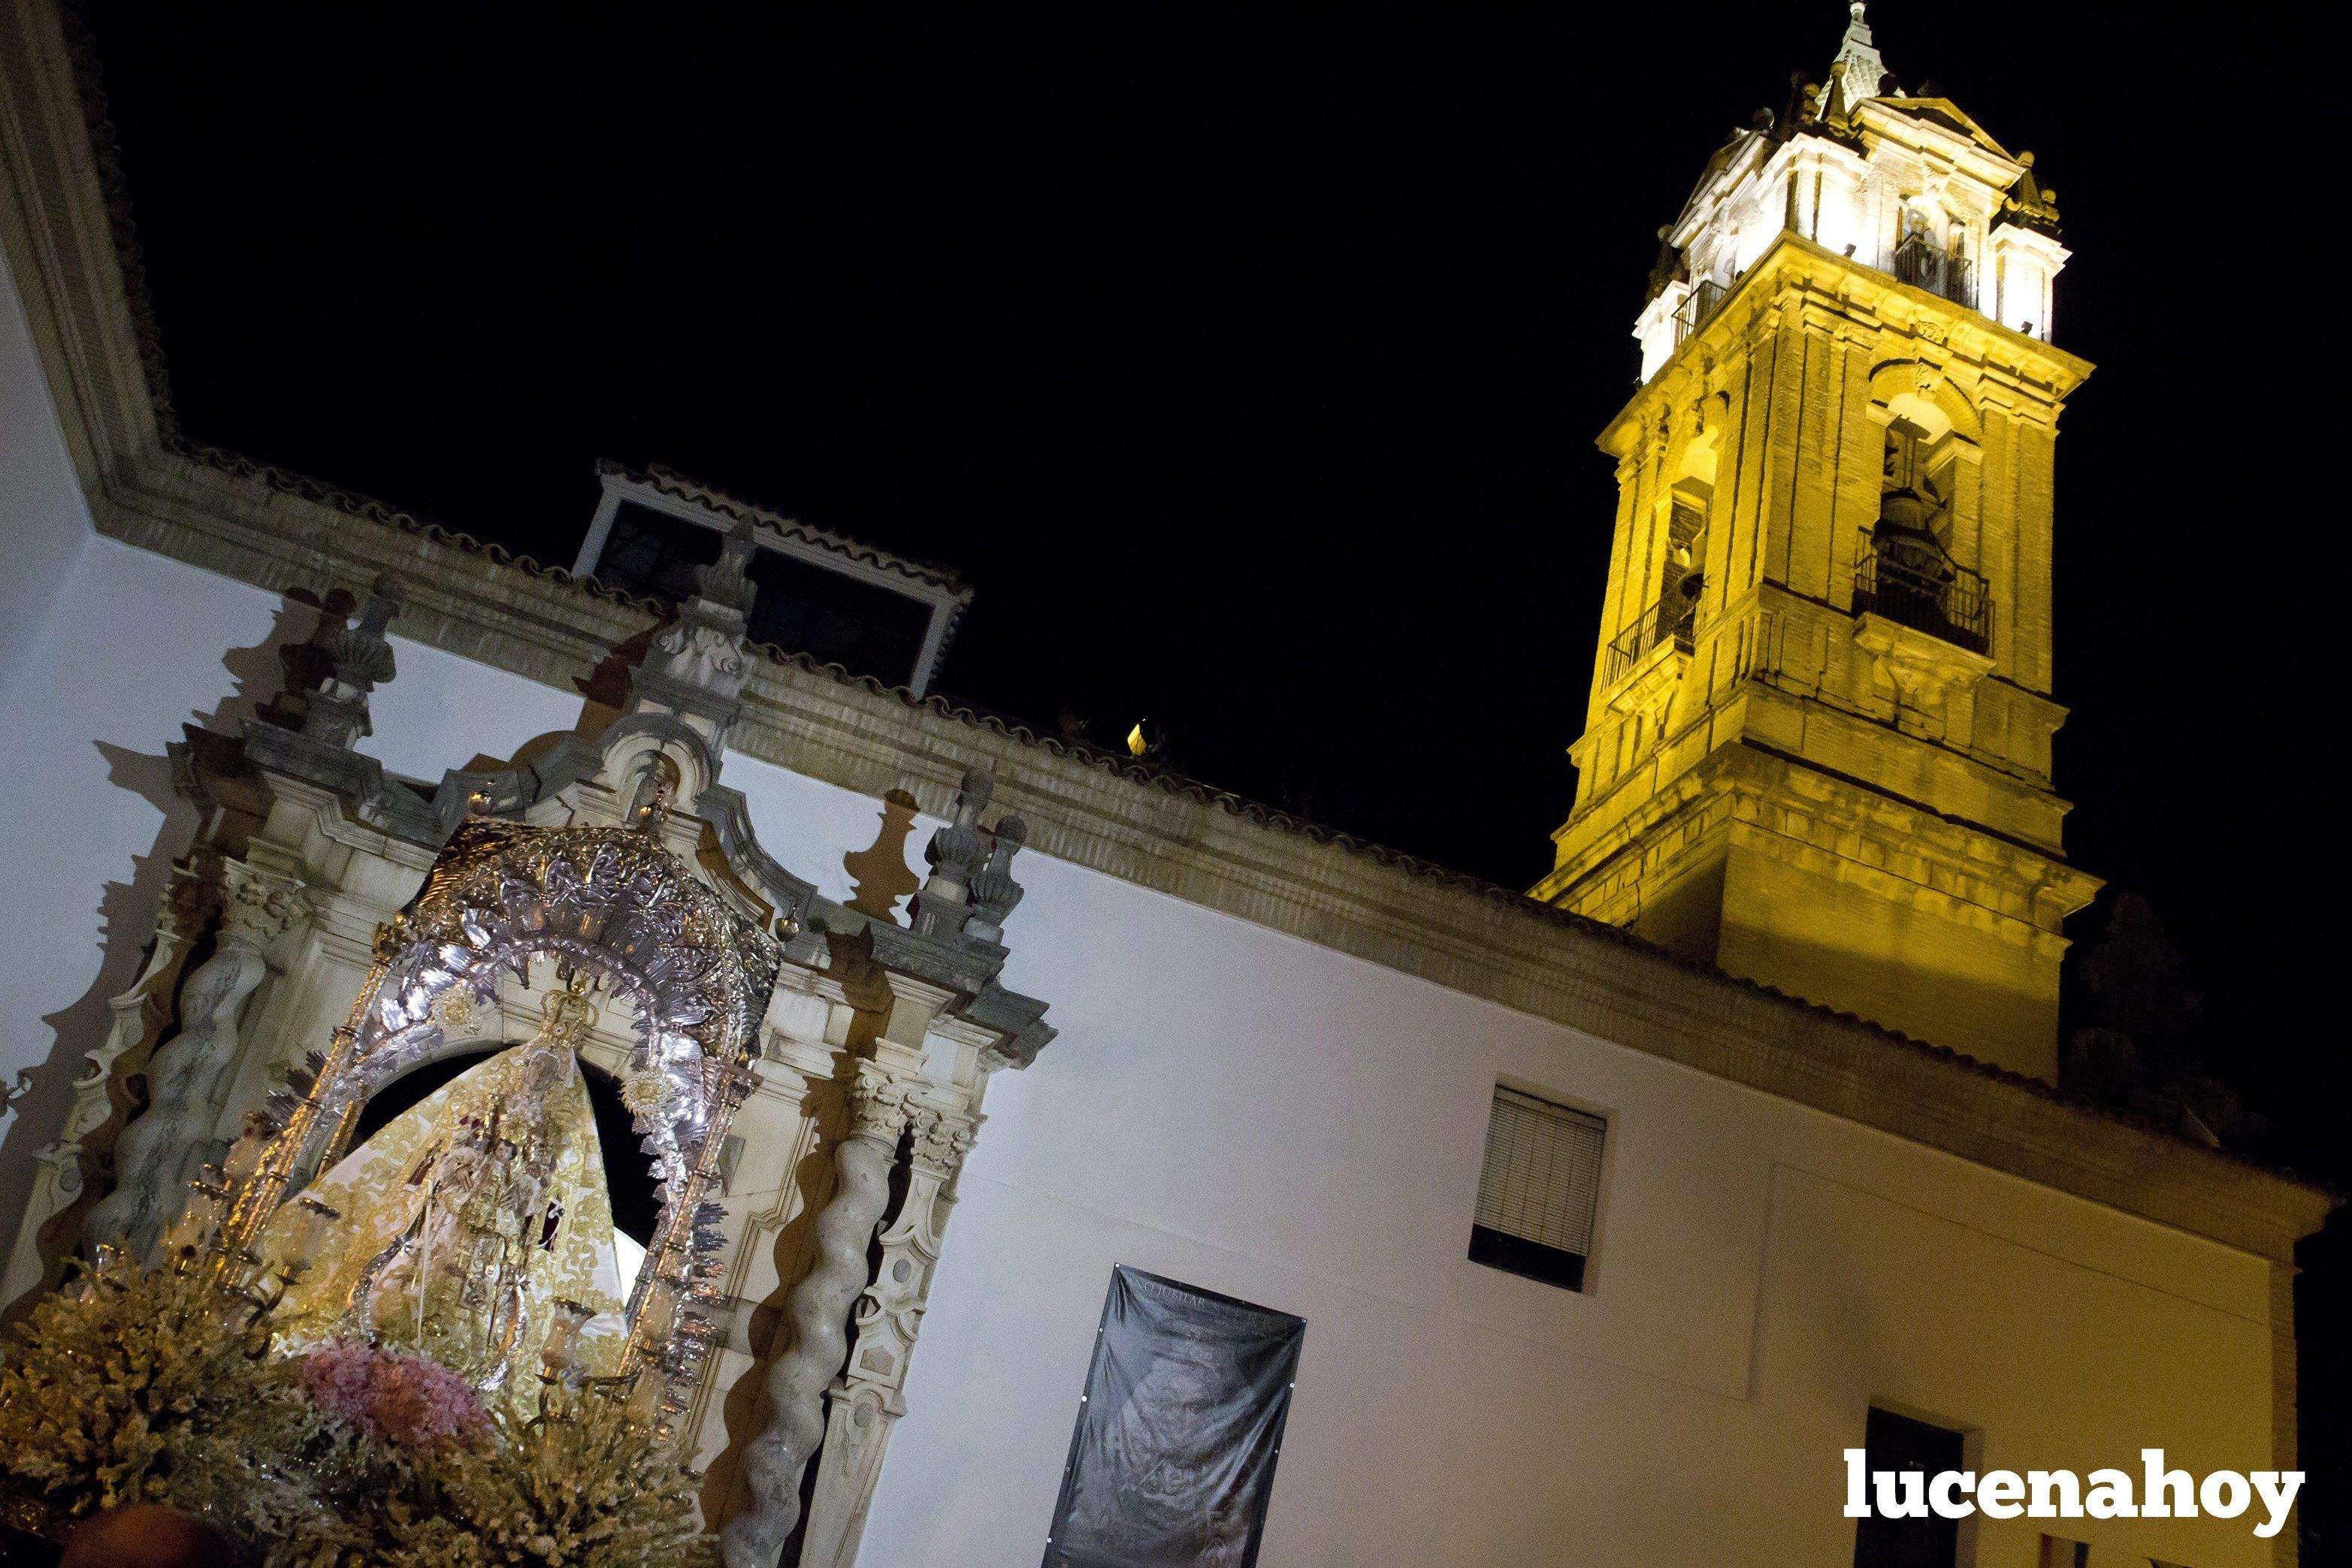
[1470, 1089, 1609, 1291]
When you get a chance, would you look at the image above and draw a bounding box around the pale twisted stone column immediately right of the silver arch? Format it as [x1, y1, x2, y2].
[720, 1060, 918, 1568]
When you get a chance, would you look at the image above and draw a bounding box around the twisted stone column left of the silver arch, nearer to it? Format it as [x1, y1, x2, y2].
[87, 860, 304, 1258]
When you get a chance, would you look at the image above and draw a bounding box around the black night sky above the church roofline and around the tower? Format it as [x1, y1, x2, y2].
[73, 0, 2352, 1528]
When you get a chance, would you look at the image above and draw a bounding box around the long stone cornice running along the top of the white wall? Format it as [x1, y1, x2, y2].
[0, 0, 2335, 1260]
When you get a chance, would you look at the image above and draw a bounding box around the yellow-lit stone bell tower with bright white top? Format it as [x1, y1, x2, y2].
[1536, 5, 2098, 1079]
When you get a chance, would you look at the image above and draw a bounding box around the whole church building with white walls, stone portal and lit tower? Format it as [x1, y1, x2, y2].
[0, 5, 2331, 1568]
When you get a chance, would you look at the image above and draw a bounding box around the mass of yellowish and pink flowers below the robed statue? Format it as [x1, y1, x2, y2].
[0, 1260, 715, 1568]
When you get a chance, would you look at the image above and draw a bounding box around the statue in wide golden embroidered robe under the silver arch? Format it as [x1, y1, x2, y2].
[261, 980, 628, 1401]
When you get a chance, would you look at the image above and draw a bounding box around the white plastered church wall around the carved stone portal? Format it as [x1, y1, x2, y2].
[0, 334, 2269, 1568]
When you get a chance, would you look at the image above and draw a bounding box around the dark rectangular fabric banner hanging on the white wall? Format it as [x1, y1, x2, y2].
[1044, 1264, 1308, 1568]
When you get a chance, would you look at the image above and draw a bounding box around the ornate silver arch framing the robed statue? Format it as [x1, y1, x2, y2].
[221, 818, 783, 1412]
